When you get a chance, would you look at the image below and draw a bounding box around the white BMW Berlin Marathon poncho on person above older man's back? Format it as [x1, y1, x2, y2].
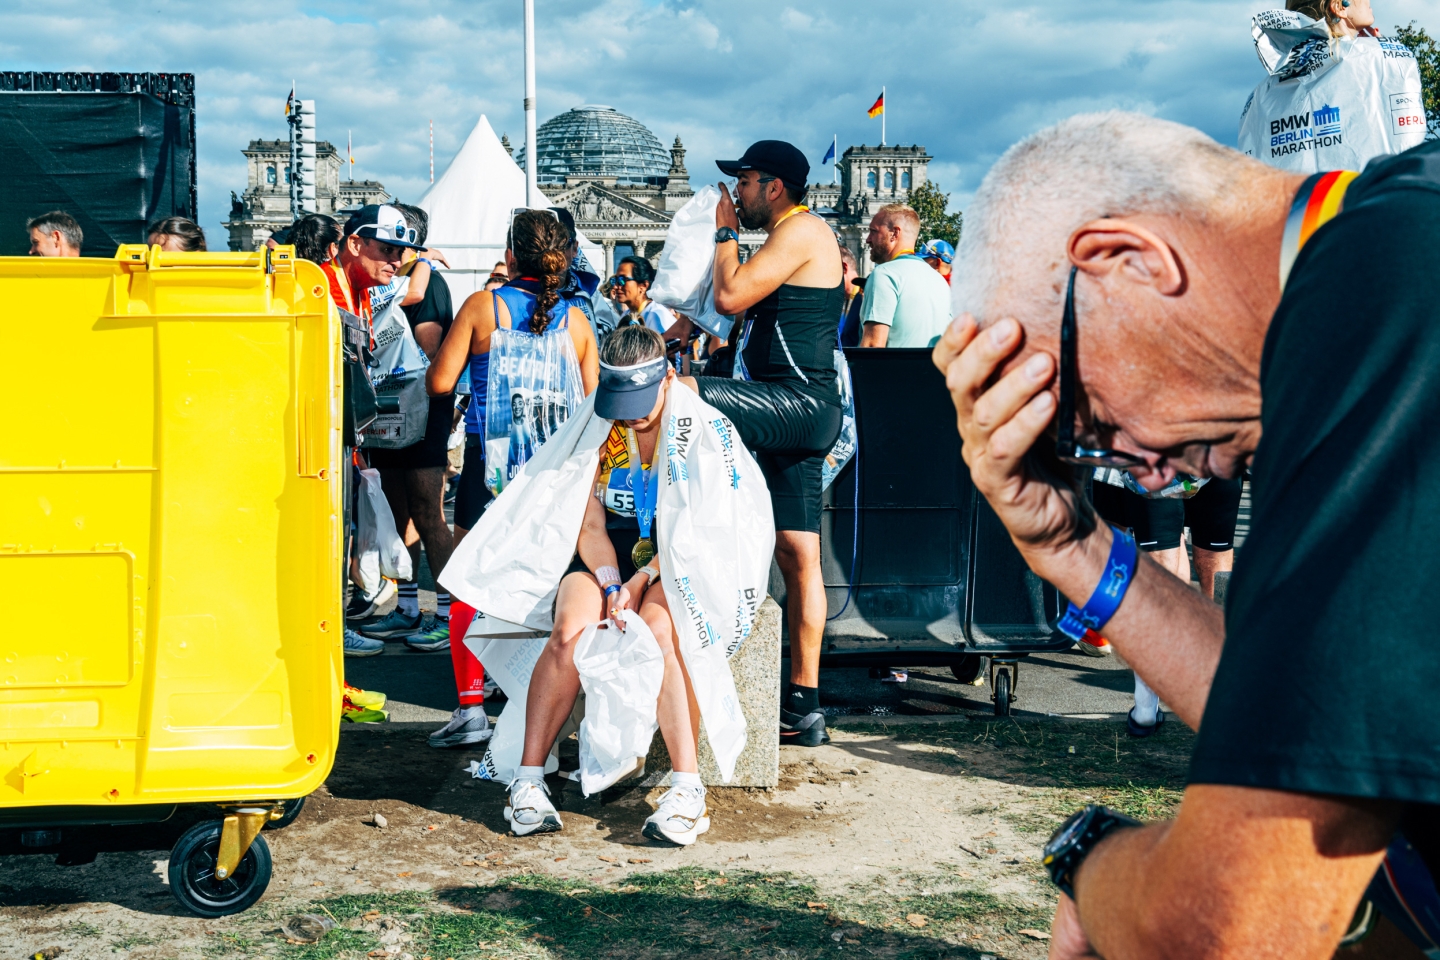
[1238, 10, 1426, 173]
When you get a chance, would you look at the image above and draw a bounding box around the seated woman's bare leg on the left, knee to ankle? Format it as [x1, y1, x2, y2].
[520, 573, 605, 767]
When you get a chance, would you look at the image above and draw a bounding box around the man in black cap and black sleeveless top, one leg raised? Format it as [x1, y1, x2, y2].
[676, 140, 845, 747]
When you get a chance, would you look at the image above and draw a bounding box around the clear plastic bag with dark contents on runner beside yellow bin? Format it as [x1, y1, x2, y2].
[360, 276, 431, 449]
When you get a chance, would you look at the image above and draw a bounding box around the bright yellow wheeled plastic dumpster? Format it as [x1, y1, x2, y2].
[0, 245, 344, 917]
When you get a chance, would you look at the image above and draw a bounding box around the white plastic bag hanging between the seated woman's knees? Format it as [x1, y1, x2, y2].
[575, 610, 665, 796]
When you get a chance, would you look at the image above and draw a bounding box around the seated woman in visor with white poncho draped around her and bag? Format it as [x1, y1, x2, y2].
[441, 325, 775, 845]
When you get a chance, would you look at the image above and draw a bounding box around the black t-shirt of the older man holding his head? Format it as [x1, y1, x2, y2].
[1189, 144, 1440, 816]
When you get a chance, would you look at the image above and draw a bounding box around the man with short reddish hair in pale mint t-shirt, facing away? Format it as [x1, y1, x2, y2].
[860, 203, 950, 347]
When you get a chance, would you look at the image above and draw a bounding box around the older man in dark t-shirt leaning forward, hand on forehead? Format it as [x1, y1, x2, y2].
[935, 112, 1440, 960]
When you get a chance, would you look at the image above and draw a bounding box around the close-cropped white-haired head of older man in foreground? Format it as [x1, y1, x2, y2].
[952, 112, 1303, 483]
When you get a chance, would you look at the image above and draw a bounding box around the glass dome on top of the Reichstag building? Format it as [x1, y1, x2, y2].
[516, 104, 670, 186]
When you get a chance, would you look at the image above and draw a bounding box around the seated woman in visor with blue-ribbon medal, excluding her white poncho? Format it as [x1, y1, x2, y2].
[505, 325, 710, 846]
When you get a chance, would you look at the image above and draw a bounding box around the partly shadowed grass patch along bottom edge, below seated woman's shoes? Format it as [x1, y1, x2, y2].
[227, 868, 1053, 960]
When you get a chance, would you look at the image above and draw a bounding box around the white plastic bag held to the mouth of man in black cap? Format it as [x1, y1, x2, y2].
[649, 184, 730, 340]
